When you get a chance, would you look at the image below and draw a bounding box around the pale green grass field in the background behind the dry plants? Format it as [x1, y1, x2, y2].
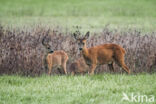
[0, 0, 156, 31]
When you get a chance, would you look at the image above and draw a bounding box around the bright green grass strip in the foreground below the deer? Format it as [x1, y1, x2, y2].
[0, 74, 156, 104]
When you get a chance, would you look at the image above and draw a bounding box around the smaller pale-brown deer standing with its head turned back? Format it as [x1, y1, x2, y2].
[42, 33, 68, 75]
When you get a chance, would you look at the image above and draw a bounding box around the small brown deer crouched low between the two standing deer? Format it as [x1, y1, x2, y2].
[70, 57, 89, 75]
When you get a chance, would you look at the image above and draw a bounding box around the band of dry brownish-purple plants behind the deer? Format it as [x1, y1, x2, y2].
[0, 26, 156, 76]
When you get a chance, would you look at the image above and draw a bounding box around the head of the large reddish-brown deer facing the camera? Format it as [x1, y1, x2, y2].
[73, 31, 89, 50]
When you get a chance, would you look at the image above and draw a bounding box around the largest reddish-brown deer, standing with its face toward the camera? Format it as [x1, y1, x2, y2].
[73, 31, 130, 75]
